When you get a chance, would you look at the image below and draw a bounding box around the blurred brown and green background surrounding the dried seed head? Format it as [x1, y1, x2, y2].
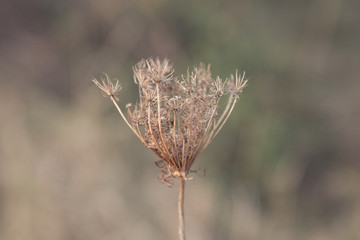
[0, 0, 360, 240]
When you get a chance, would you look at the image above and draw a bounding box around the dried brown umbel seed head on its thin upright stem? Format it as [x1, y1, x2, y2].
[93, 58, 247, 240]
